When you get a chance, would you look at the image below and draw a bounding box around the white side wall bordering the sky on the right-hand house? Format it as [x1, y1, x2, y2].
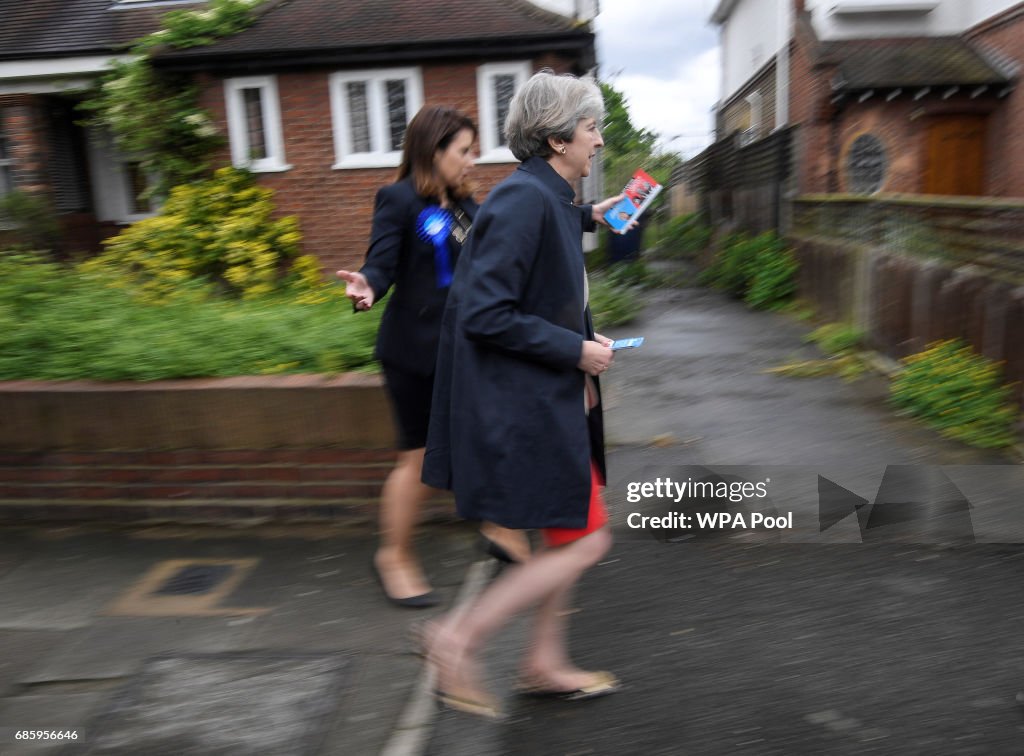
[721, 0, 793, 100]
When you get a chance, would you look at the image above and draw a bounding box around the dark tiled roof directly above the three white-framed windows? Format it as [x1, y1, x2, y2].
[152, 0, 592, 61]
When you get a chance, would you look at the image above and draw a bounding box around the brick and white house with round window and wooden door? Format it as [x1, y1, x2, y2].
[712, 0, 1024, 198]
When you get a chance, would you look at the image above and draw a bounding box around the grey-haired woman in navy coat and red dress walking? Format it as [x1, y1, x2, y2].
[422, 71, 621, 717]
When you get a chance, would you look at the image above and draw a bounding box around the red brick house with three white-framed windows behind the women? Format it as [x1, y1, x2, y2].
[0, 0, 595, 269]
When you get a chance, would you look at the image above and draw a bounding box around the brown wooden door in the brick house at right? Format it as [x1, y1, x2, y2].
[922, 115, 985, 195]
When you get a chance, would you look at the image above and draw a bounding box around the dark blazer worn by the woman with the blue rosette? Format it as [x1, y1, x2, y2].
[359, 177, 479, 377]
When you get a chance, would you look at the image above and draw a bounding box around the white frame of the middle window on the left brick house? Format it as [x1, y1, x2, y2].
[328, 68, 423, 170]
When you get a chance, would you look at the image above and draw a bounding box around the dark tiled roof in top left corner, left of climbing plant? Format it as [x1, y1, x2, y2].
[0, 0, 205, 60]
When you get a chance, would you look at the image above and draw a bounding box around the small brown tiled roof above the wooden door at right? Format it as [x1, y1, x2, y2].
[823, 37, 1011, 91]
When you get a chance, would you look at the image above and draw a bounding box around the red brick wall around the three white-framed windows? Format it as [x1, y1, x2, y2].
[192, 55, 568, 271]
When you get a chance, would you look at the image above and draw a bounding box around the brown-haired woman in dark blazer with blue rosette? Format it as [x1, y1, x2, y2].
[338, 107, 525, 608]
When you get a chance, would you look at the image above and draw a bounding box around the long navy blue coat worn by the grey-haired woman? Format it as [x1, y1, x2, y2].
[423, 158, 604, 528]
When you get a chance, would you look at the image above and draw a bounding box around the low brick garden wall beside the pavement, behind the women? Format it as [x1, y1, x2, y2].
[0, 374, 452, 521]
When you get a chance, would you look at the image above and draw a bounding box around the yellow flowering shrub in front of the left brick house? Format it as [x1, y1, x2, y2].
[83, 168, 324, 301]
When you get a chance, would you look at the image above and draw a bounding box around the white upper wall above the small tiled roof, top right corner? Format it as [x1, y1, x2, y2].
[807, 0, 1019, 39]
